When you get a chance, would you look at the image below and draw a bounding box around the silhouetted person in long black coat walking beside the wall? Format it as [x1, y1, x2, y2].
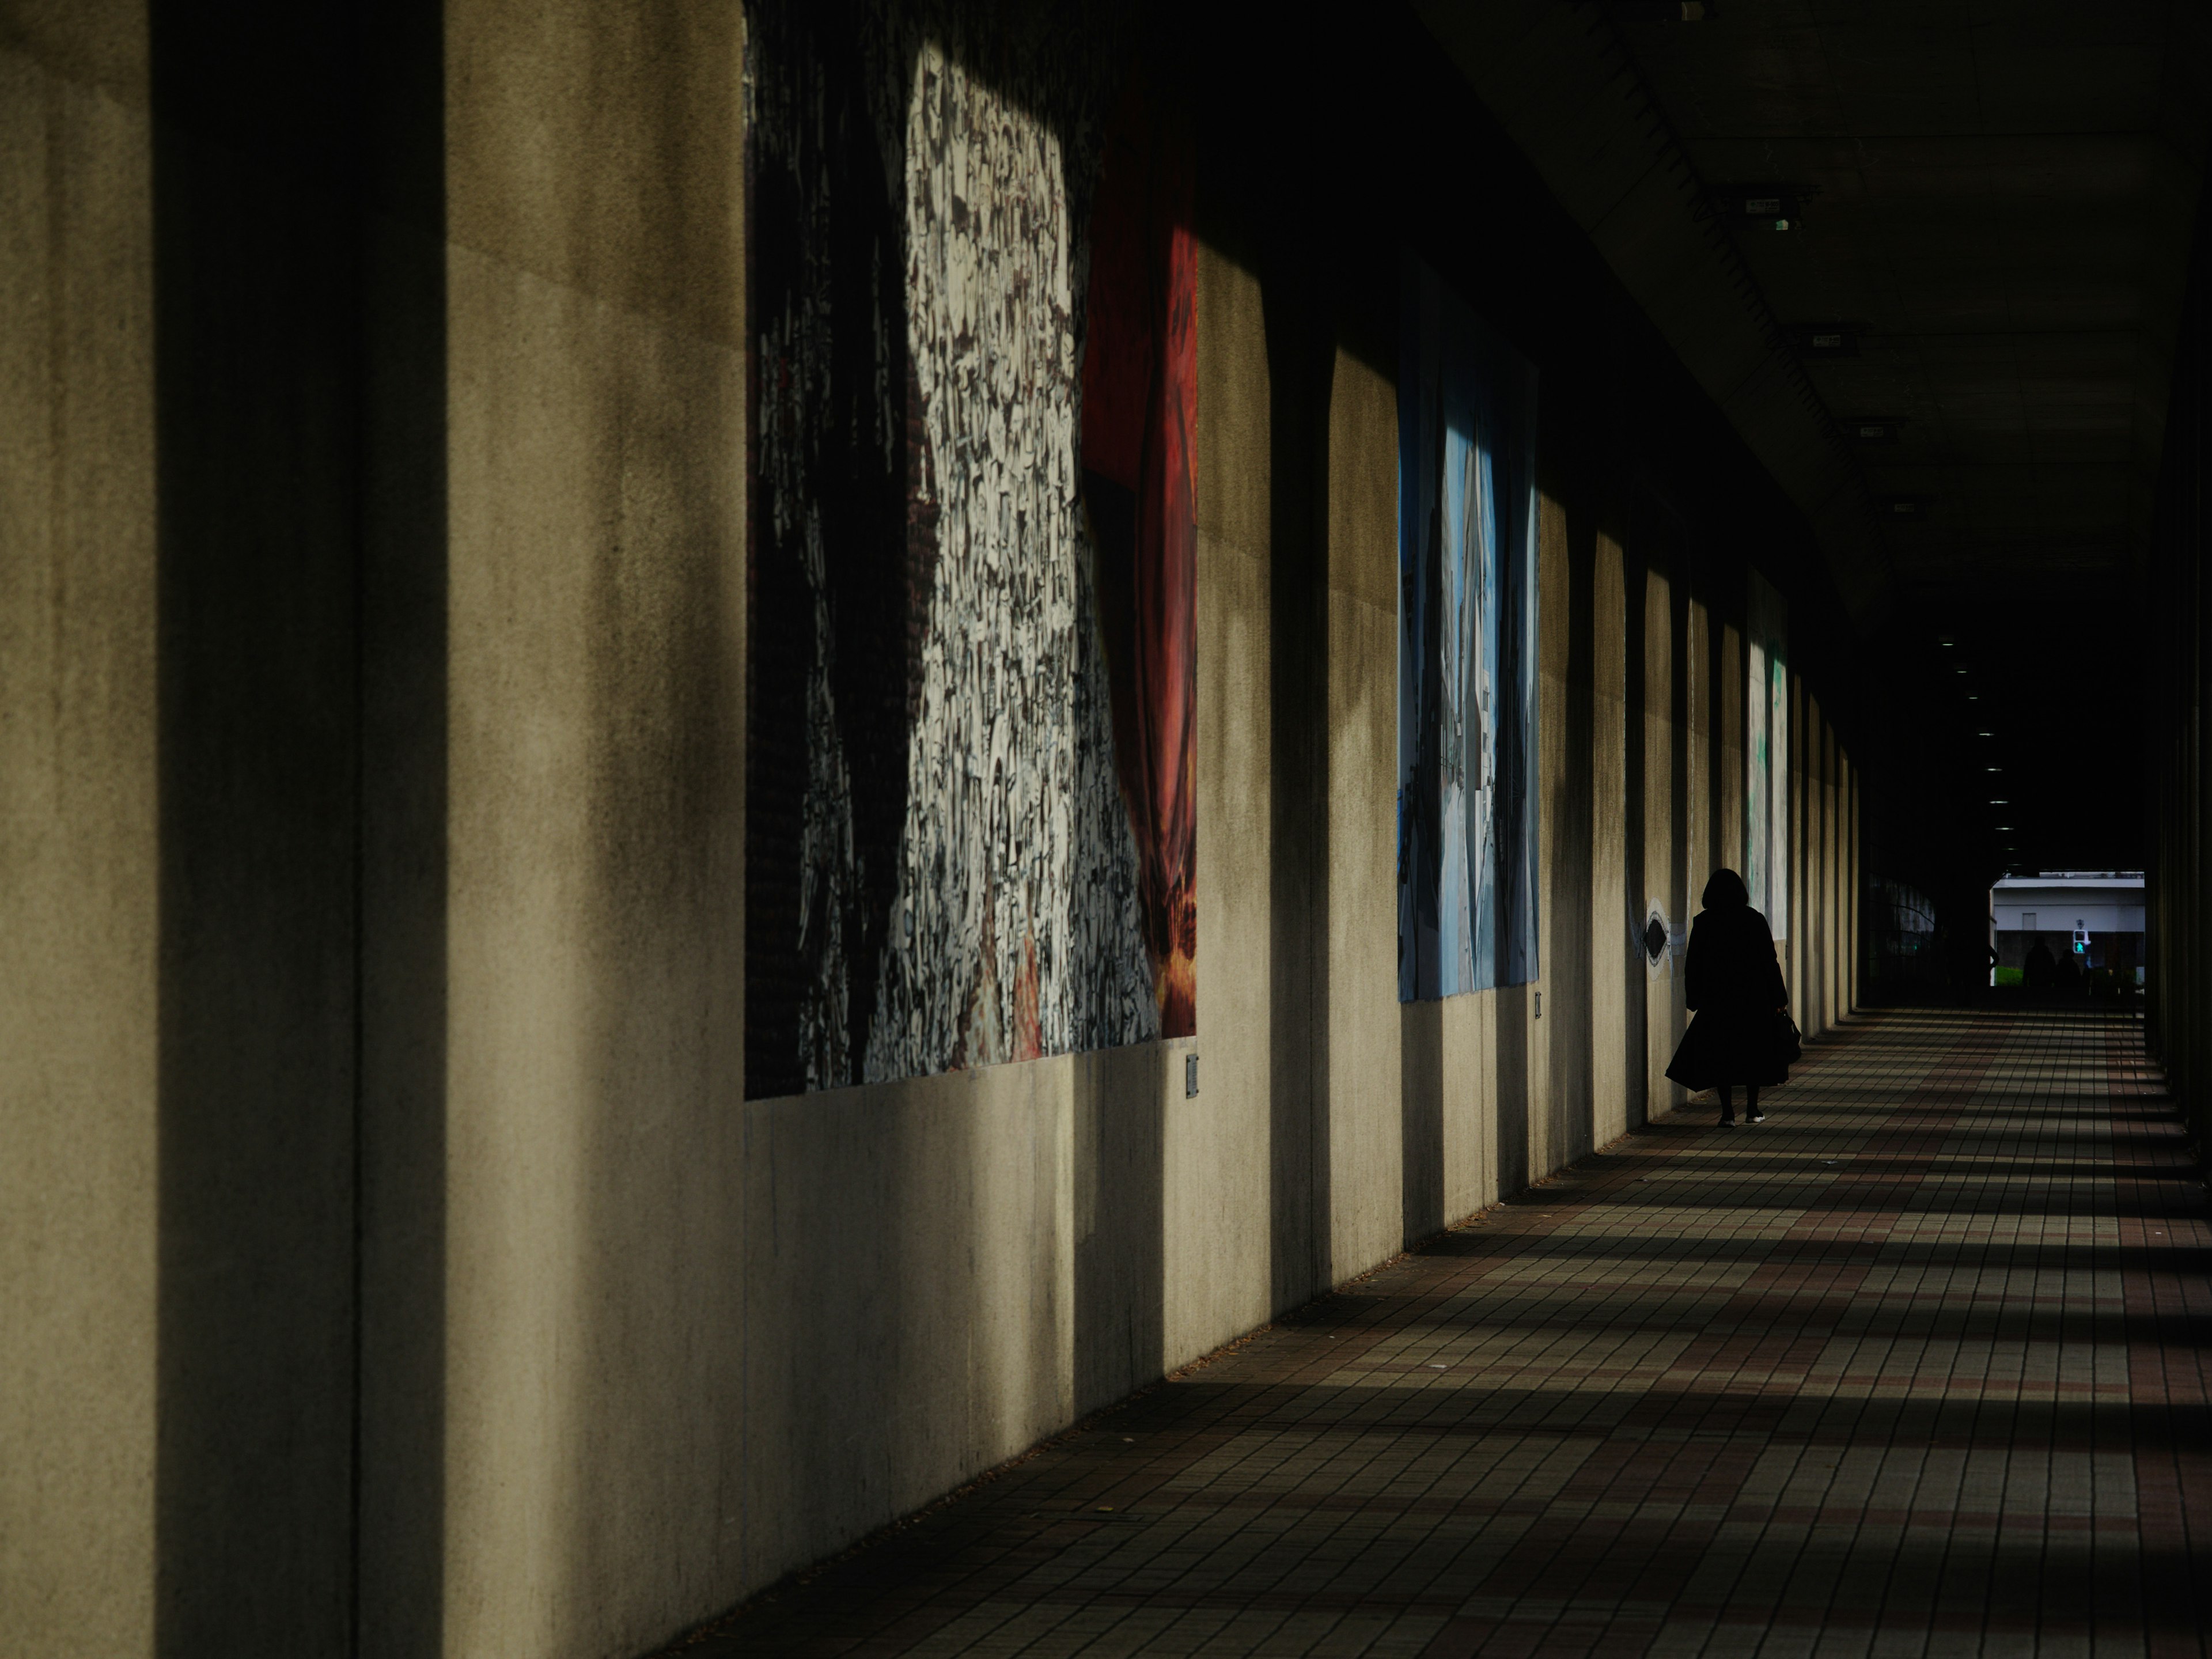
[1666, 869, 1796, 1126]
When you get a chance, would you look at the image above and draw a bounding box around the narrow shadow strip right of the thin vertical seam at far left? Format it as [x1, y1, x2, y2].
[354, 0, 449, 1659]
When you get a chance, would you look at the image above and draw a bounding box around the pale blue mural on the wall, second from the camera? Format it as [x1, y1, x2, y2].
[1398, 259, 1537, 1002]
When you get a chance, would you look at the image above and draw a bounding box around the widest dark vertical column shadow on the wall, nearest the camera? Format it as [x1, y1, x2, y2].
[148, 0, 445, 1654]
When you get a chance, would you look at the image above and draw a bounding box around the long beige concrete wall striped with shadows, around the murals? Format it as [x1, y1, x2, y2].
[0, 0, 1856, 1659]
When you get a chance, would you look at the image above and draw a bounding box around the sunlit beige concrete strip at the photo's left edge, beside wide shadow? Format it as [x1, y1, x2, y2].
[0, 16, 159, 1659]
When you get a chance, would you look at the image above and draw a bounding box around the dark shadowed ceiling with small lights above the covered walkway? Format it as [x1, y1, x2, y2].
[1418, 0, 2212, 878]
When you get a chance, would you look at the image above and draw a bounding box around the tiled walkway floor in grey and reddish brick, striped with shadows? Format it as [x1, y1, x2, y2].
[690, 1013, 2212, 1659]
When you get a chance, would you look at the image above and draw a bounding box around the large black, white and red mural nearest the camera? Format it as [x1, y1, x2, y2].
[745, 0, 1196, 1097]
